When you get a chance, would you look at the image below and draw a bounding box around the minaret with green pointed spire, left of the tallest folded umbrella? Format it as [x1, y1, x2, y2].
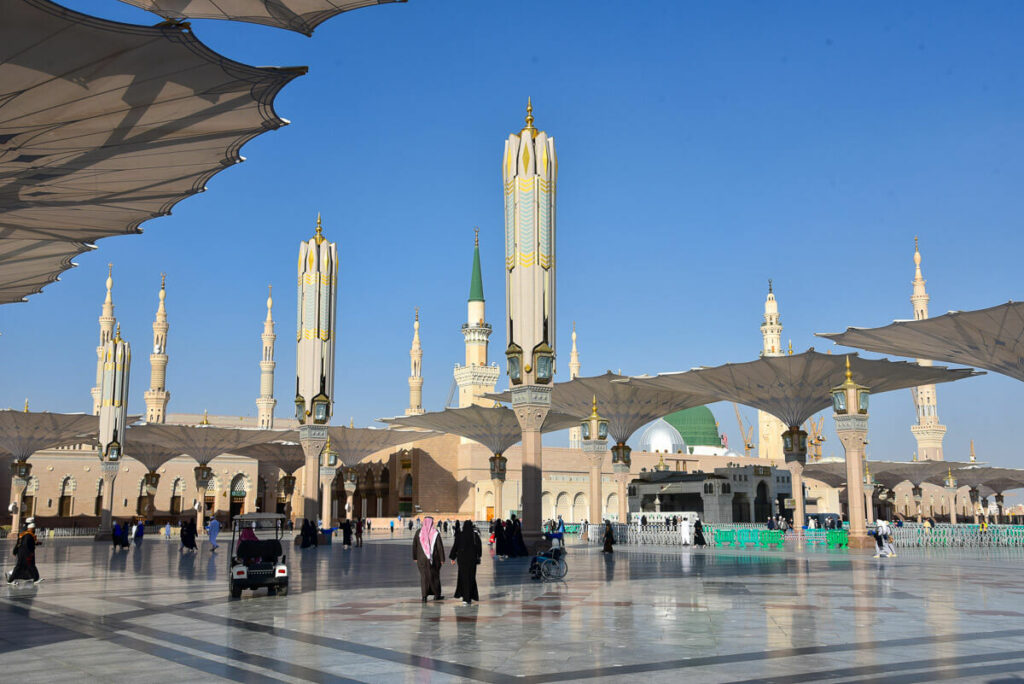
[455, 228, 501, 409]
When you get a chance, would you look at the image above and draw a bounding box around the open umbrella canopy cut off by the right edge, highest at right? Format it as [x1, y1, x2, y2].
[818, 302, 1024, 381]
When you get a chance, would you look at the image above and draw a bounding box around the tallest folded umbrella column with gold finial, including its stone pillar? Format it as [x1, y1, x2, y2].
[502, 103, 558, 546]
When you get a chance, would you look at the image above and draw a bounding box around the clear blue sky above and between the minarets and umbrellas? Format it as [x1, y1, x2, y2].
[0, 0, 1024, 479]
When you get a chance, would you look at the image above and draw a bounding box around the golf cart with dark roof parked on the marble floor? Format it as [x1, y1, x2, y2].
[227, 513, 288, 598]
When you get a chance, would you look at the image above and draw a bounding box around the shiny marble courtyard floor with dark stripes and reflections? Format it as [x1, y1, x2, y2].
[0, 537, 1024, 683]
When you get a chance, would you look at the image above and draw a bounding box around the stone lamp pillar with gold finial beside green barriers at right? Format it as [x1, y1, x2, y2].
[831, 356, 871, 549]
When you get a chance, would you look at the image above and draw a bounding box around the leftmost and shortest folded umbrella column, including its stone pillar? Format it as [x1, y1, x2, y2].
[95, 325, 131, 541]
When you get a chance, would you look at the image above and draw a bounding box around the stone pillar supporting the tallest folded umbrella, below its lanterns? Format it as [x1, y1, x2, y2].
[512, 385, 551, 550]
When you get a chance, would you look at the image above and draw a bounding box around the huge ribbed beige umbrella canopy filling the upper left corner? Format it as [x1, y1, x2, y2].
[0, 0, 305, 303]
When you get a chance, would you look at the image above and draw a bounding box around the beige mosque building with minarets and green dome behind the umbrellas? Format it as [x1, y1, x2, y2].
[6, 111, 971, 526]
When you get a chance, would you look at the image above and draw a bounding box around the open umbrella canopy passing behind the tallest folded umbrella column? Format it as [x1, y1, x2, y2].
[381, 405, 580, 454]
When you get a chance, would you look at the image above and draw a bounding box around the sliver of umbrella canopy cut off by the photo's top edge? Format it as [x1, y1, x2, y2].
[121, 0, 406, 36]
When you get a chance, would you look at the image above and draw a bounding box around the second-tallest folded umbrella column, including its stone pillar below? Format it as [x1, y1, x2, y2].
[295, 214, 338, 521]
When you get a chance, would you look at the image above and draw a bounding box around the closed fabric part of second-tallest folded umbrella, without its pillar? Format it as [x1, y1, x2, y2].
[295, 214, 338, 423]
